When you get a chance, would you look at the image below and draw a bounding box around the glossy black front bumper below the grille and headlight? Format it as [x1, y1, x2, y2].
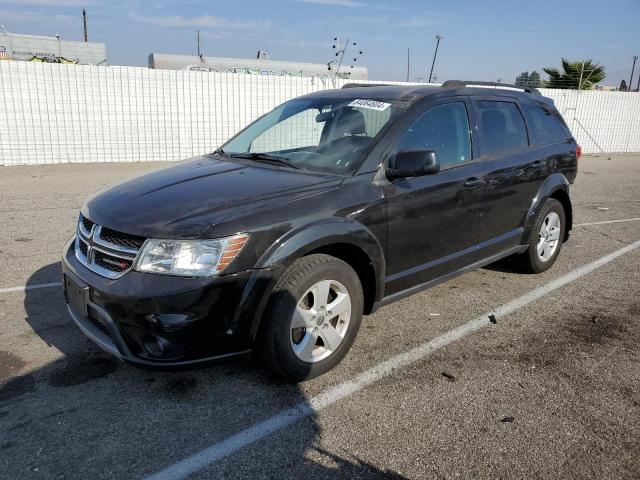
[62, 239, 274, 369]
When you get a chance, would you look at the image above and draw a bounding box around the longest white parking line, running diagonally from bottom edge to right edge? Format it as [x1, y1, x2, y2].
[146, 240, 640, 480]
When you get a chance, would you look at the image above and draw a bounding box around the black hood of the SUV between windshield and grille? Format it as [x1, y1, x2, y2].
[82, 156, 342, 238]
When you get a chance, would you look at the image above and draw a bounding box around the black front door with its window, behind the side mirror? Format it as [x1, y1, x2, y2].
[385, 97, 485, 295]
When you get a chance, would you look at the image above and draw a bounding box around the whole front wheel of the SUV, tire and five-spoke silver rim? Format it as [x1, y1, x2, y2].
[257, 254, 364, 381]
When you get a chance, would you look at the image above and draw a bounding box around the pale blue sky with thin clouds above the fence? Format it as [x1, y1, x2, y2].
[0, 0, 640, 85]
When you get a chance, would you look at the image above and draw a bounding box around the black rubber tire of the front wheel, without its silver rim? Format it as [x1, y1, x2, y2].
[256, 254, 364, 381]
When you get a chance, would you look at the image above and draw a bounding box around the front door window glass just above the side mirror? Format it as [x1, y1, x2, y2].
[397, 102, 471, 166]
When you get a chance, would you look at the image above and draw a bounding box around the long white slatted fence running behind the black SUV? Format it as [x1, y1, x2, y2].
[0, 62, 640, 165]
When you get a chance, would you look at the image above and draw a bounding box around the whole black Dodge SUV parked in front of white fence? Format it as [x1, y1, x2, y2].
[63, 81, 580, 380]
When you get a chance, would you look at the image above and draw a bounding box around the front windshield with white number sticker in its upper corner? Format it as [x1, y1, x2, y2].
[222, 98, 401, 174]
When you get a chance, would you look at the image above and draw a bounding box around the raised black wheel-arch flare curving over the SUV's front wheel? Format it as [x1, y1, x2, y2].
[236, 218, 385, 339]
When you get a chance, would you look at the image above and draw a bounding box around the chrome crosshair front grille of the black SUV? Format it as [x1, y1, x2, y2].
[75, 216, 146, 278]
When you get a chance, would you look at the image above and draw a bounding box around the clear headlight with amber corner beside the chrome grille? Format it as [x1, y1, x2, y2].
[135, 235, 249, 277]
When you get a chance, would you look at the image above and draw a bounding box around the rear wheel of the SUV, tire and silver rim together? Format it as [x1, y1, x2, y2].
[517, 198, 566, 273]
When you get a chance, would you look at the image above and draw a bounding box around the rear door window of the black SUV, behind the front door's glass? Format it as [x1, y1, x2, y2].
[477, 100, 529, 155]
